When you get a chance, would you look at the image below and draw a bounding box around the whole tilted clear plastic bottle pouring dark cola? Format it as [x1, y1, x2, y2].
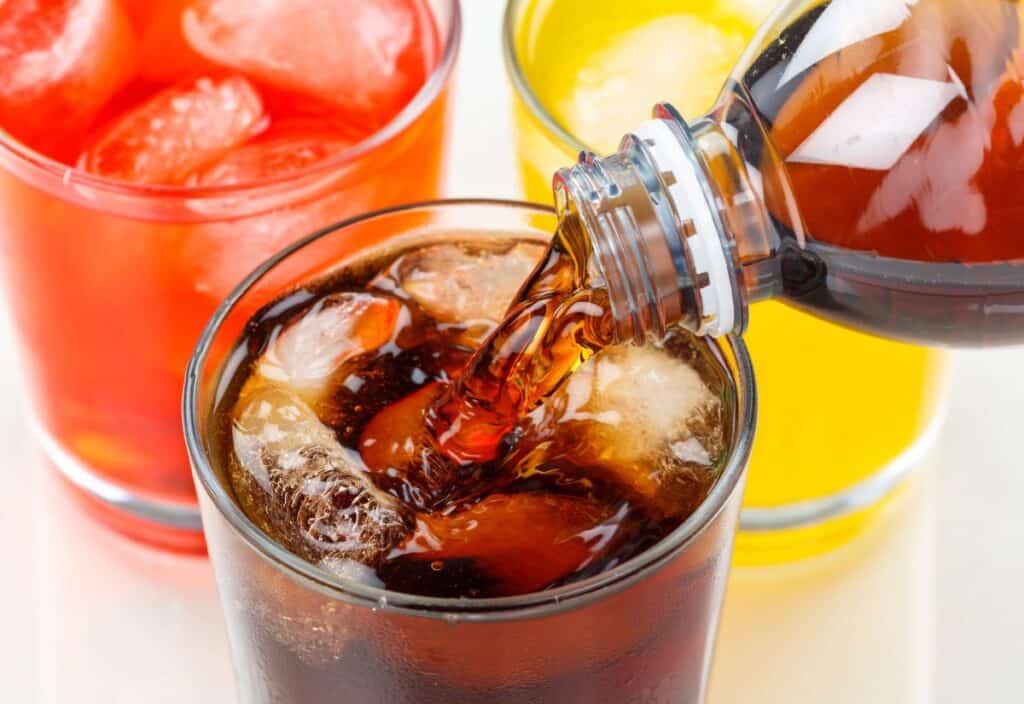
[556, 0, 1024, 346]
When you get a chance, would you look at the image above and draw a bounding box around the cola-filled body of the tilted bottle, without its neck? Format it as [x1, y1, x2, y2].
[713, 0, 1024, 345]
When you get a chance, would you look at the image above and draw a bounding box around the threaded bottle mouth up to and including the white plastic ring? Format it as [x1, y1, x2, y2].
[554, 105, 735, 342]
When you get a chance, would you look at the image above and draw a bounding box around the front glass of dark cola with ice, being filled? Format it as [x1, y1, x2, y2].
[184, 201, 756, 704]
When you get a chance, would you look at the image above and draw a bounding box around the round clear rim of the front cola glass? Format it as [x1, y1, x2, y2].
[182, 199, 757, 621]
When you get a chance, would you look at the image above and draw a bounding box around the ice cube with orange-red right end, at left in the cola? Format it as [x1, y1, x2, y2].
[258, 292, 402, 405]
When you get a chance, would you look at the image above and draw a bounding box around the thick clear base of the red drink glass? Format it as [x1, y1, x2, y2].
[34, 424, 206, 553]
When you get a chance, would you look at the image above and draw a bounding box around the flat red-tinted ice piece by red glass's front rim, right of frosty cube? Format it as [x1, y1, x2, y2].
[196, 123, 353, 185]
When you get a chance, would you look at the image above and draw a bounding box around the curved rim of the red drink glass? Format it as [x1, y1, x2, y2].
[0, 0, 462, 215]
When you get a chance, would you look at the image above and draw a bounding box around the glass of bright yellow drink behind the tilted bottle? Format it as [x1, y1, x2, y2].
[505, 0, 945, 565]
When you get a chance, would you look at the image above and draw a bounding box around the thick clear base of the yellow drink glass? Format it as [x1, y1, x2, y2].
[733, 404, 945, 567]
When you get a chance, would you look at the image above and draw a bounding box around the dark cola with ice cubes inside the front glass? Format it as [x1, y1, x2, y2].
[216, 233, 733, 598]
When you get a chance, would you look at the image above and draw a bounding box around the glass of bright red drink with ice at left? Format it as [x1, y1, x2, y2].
[0, 0, 460, 549]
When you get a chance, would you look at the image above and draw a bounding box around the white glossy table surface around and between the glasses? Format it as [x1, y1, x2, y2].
[0, 0, 1024, 704]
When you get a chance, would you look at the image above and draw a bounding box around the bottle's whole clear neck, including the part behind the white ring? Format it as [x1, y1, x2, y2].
[554, 104, 774, 340]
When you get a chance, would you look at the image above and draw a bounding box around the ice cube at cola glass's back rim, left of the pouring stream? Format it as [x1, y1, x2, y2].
[390, 243, 545, 331]
